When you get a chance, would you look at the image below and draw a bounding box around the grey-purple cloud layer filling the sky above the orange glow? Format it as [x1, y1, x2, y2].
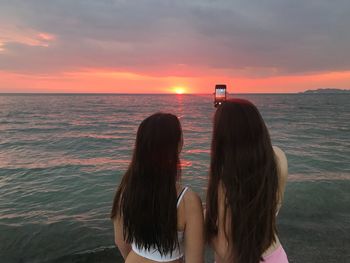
[0, 0, 350, 74]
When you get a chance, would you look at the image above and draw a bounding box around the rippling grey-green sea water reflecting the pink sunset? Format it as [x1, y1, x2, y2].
[0, 94, 350, 263]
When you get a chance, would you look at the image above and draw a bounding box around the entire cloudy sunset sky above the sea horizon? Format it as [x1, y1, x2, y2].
[0, 0, 350, 93]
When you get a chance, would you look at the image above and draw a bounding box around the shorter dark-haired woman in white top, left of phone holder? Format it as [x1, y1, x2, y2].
[111, 113, 204, 263]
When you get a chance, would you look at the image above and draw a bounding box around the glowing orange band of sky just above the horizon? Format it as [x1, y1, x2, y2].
[0, 70, 350, 93]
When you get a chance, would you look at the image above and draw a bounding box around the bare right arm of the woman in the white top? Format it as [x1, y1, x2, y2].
[184, 190, 204, 263]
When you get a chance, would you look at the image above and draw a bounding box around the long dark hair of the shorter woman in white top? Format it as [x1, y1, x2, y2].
[111, 113, 182, 254]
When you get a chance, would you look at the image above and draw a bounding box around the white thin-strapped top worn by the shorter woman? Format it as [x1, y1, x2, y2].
[131, 186, 188, 262]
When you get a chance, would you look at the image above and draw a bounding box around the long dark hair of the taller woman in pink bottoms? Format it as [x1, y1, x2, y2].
[206, 99, 278, 263]
